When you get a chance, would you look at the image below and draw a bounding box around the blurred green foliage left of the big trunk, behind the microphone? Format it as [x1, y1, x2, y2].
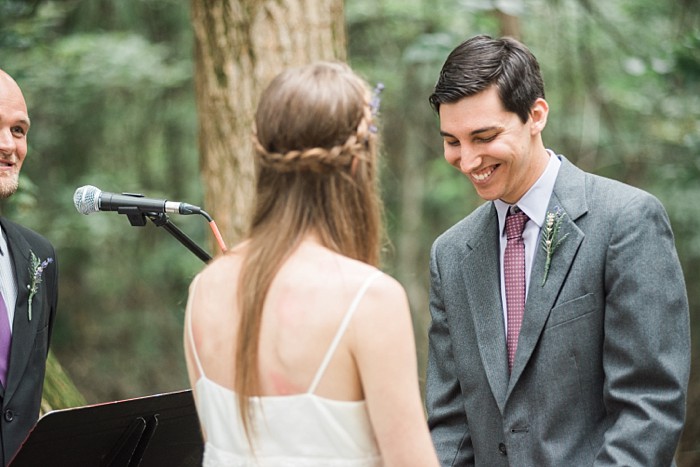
[0, 1, 202, 402]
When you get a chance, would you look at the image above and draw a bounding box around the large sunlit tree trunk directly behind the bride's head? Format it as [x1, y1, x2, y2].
[191, 0, 346, 252]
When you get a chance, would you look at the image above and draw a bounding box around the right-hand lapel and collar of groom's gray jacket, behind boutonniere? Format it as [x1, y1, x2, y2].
[507, 157, 588, 396]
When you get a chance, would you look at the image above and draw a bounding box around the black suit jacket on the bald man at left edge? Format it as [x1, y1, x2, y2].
[0, 217, 58, 465]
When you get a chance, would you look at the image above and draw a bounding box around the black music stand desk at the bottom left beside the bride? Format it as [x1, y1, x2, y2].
[9, 390, 204, 467]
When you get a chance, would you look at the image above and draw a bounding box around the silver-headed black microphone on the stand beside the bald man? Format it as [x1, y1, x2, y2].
[73, 185, 204, 215]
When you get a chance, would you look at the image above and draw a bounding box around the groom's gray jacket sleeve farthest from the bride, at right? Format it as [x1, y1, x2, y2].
[595, 193, 690, 466]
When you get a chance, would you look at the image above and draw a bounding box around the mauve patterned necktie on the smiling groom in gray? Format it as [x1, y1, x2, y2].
[503, 207, 528, 370]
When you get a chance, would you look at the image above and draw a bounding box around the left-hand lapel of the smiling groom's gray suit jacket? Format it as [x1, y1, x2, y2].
[462, 203, 508, 412]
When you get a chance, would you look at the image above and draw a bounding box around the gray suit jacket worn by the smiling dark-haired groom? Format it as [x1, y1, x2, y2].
[426, 158, 690, 467]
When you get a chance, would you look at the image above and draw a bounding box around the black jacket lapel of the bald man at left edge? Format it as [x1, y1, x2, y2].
[2, 222, 43, 400]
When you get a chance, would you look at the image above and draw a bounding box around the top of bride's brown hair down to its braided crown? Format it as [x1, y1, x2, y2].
[253, 62, 376, 173]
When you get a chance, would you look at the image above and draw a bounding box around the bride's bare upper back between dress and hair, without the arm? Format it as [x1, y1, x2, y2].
[193, 241, 386, 400]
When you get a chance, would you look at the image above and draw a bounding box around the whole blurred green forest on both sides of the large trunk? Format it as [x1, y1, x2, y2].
[0, 0, 700, 466]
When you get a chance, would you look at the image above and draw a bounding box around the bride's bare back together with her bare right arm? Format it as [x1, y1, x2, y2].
[186, 237, 437, 466]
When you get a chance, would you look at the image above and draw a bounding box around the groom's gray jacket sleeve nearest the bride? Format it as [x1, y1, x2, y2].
[426, 241, 474, 466]
